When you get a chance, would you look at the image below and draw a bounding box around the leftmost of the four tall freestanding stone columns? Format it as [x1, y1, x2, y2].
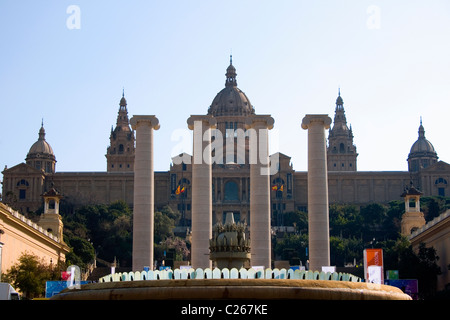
[130, 116, 159, 271]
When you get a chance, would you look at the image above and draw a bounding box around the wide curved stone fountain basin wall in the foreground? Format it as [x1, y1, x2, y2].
[51, 279, 411, 300]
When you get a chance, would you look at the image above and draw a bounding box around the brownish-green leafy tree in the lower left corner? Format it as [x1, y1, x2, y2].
[4, 252, 62, 299]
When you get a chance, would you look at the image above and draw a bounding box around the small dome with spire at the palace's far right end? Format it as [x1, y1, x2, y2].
[407, 119, 438, 172]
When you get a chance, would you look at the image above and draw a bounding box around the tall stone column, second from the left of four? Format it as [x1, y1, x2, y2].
[187, 116, 216, 269]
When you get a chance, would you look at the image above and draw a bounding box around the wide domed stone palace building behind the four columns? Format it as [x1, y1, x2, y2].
[2, 60, 450, 227]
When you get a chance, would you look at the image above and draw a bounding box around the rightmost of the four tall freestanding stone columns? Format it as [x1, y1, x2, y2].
[302, 114, 331, 271]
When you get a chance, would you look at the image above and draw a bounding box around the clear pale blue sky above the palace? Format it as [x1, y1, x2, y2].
[0, 0, 450, 175]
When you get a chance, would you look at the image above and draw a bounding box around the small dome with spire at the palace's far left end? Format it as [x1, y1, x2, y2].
[25, 121, 56, 173]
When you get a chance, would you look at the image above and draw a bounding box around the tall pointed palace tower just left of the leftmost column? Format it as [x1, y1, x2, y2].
[106, 93, 134, 172]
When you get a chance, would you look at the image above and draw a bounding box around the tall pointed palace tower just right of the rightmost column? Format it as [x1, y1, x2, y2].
[327, 90, 358, 171]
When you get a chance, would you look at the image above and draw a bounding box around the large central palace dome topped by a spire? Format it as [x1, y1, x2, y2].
[208, 58, 255, 117]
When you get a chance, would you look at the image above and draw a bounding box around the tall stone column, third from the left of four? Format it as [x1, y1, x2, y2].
[246, 115, 274, 268]
